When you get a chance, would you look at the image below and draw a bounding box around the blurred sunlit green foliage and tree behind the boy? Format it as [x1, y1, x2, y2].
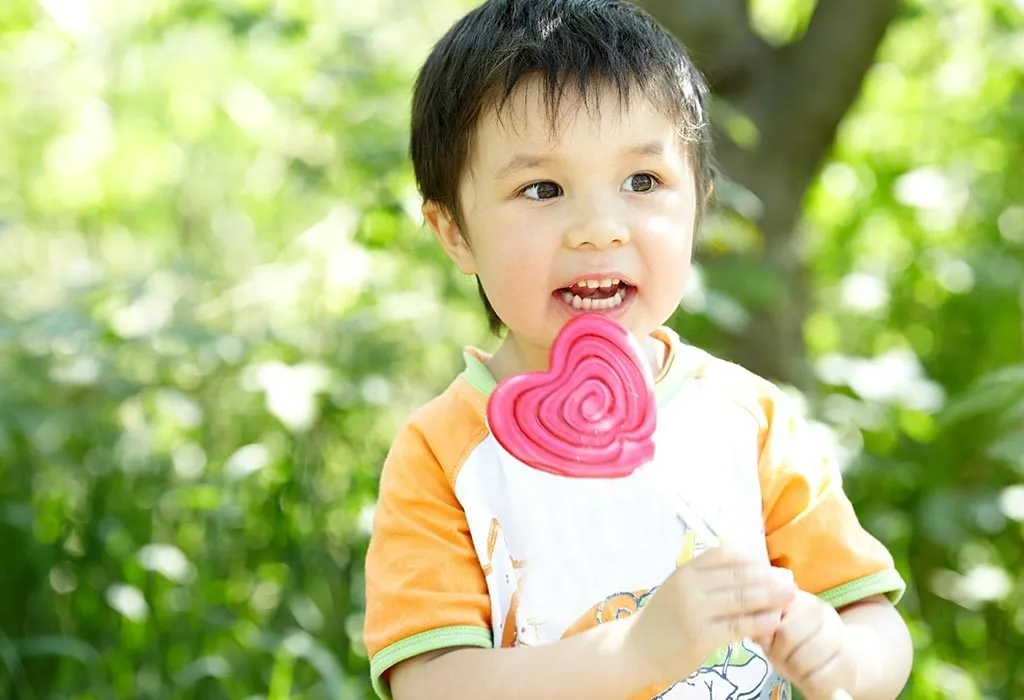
[0, 0, 1024, 700]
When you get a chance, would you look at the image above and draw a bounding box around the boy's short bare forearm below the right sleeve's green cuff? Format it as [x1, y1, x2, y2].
[840, 596, 913, 700]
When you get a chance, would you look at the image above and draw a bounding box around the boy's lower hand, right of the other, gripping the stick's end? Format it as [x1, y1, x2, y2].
[755, 590, 857, 700]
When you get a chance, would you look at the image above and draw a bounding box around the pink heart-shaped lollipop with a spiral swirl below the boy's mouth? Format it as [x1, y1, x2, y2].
[487, 314, 656, 478]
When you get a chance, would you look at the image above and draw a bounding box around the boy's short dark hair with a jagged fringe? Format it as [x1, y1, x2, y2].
[410, 0, 713, 334]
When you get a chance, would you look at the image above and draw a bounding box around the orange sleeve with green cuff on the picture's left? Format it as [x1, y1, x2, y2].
[364, 423, 492, 698]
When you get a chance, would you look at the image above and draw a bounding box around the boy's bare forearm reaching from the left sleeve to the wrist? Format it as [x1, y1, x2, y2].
[391, 617, 655, 700]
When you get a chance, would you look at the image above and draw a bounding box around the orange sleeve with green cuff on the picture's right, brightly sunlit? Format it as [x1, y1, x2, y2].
[759, 392, 905, 608]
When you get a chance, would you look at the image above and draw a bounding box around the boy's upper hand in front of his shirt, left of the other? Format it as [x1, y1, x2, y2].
[629, 546, 797, 684]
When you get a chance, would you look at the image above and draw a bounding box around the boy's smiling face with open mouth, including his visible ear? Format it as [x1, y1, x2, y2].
[428, 78, 696, 356]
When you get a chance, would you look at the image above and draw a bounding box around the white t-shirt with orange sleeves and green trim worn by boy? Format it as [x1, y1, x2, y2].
[364, 329, 905, 700]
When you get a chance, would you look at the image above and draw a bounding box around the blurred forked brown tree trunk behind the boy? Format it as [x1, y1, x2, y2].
[637, 0, 899, 389]
